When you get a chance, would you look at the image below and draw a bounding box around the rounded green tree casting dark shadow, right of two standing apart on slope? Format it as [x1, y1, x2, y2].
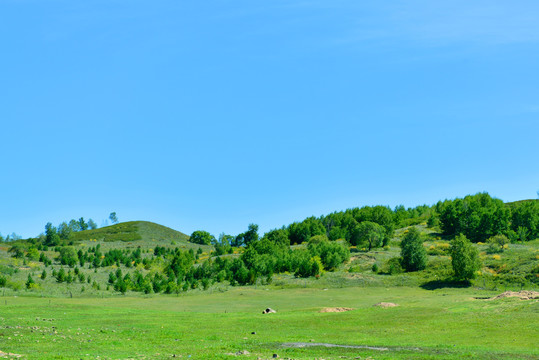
[449, 234, 481, 281]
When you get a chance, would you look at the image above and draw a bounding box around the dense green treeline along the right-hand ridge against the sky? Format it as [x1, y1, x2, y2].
[190, 193, 539, 252]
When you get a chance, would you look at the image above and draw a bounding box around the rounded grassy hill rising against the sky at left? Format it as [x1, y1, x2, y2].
[71, 221, 189, 242]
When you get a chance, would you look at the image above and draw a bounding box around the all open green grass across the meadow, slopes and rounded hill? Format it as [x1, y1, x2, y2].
[0, 222, 539, 359]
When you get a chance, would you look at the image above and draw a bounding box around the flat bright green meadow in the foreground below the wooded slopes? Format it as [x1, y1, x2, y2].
[0, 286, 539, 359]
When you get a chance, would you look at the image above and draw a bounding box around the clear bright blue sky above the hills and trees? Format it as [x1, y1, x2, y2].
[0, 0, 539, 237]
